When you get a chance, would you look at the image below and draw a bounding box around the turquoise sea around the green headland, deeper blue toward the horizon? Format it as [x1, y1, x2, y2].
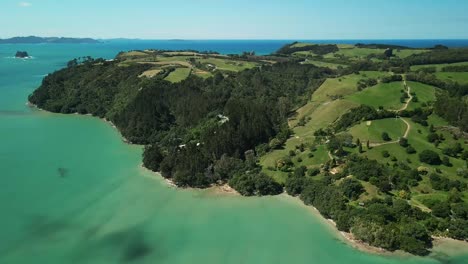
[0, 40, 468, 264]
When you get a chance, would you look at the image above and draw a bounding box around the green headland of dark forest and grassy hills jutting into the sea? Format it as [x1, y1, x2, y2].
[29, 43, 468, 255]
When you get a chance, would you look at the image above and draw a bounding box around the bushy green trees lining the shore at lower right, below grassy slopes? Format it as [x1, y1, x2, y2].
[285, 155, 468, 255]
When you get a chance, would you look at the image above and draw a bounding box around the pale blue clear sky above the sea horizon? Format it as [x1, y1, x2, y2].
[0, 0, 468, 39]
